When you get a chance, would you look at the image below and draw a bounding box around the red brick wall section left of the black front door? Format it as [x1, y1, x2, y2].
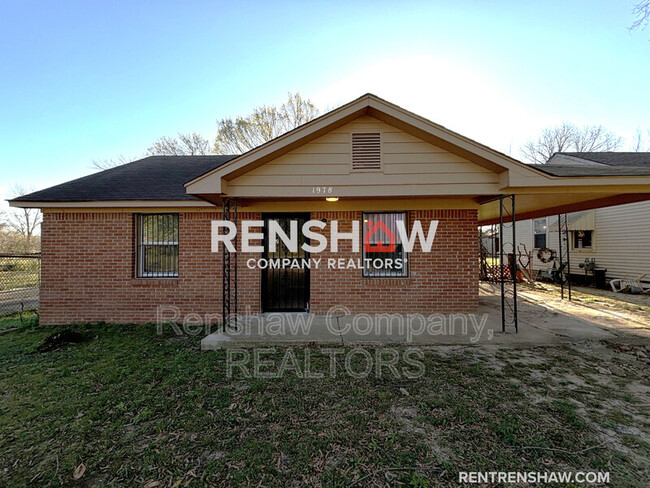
[40, 212, 260, 324]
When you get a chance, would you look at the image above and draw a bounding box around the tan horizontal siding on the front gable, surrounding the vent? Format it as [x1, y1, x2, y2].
[223, 116, 498, 196]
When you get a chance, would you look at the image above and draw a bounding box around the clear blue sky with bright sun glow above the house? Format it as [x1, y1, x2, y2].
[0, 0, 650, 207]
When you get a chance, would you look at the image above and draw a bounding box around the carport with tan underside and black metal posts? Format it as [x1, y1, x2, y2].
[477, 153, 650, 332]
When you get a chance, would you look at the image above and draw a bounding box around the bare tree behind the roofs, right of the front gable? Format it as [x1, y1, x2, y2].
[521, 122, 623, 164]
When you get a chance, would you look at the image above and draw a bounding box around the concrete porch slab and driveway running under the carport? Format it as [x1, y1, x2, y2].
[201, 284, 650, 350]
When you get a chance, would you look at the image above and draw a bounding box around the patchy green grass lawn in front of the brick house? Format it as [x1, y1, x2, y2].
[0, 319, 650, 487]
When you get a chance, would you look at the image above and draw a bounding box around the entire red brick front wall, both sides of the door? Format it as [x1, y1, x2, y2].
[40, 210, 478, 324]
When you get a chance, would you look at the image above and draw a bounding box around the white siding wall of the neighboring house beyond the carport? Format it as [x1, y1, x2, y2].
[504, 201, 650, 279]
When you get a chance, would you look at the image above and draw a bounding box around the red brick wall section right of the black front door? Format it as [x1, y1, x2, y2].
[311, 210, 479, 314]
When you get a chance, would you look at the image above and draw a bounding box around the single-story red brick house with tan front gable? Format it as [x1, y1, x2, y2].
[10, 94, 650, 324]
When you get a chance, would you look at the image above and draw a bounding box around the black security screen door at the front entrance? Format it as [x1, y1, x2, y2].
[262, 213, 309, 312]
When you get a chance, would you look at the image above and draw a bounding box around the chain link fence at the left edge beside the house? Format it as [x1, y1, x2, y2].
[0, 254, 41, 317]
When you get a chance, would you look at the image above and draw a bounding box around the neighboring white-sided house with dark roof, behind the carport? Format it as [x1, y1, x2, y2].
[504, 152, 650, 279]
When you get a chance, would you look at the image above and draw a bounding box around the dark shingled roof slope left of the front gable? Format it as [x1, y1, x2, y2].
[12, 155, 235, 202]
